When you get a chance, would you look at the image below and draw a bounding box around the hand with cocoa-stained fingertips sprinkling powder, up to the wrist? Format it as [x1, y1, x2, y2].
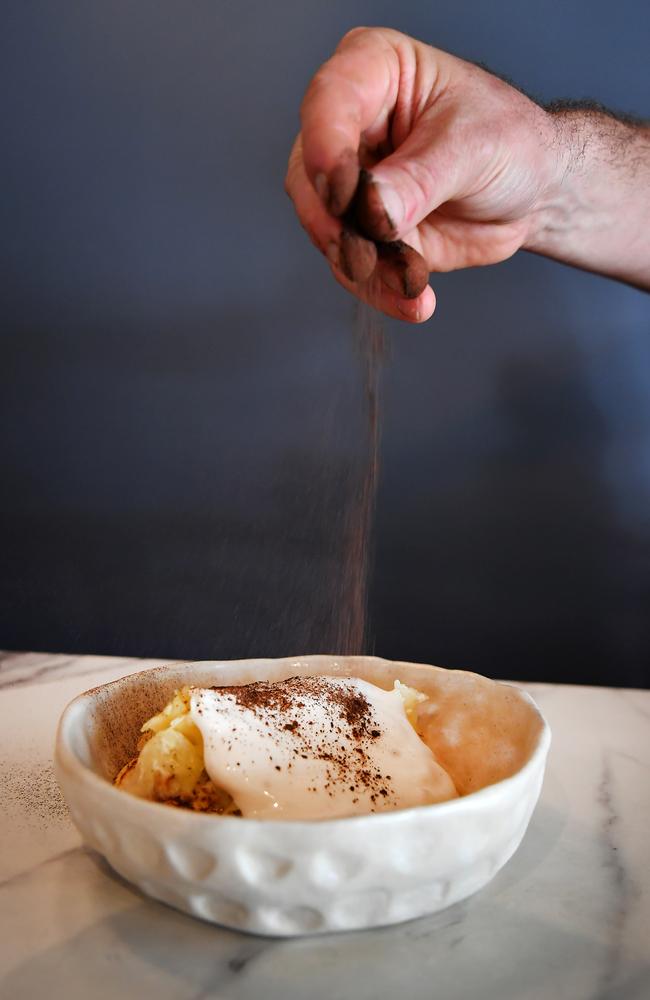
[286, 28, 561, 322]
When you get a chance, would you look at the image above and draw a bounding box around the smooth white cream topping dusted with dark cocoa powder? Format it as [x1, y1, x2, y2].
[190, 677, 457, 819]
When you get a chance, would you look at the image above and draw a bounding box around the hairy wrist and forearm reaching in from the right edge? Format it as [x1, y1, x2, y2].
[524, 109, 650, 290]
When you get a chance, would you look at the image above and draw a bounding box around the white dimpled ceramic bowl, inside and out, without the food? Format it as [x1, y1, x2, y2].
[55, 656, 550, 936]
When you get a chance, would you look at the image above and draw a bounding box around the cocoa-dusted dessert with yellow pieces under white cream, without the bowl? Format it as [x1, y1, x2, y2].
[115, 674, 458, 820]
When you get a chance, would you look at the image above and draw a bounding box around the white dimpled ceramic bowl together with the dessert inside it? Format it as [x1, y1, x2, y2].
[56, 656, 550, 936]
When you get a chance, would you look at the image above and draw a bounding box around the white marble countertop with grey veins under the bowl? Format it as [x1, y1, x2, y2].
[0, 653, 650, 1000]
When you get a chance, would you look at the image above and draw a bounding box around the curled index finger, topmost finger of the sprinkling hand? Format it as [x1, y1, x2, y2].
[301, 29, 400, 216]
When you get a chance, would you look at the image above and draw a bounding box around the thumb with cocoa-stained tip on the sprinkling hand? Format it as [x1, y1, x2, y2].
[354, 119, 460, 240]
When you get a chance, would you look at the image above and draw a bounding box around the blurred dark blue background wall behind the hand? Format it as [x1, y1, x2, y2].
[0, 0, 650, 686]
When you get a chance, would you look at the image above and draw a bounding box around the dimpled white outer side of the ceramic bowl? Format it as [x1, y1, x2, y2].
[55, 661, 550, 937]
